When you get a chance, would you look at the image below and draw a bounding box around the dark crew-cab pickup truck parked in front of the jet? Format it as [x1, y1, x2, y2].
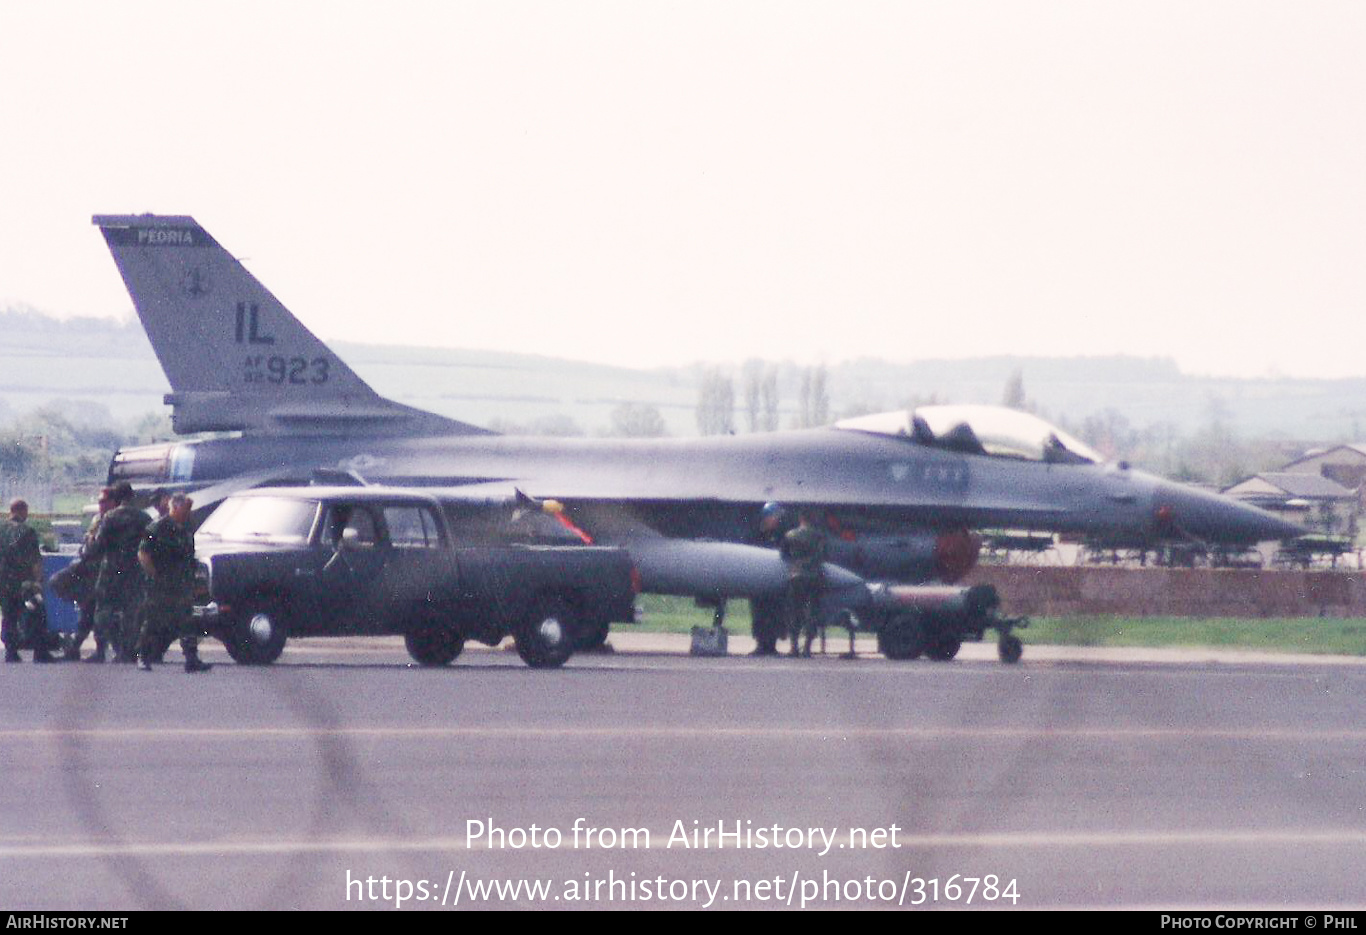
[194, 487, 637, 668]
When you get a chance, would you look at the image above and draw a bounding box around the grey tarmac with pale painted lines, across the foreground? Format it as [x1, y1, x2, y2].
[0, 632, 1366, 910]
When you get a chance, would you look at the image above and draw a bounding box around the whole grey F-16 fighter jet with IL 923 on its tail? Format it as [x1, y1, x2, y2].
[93, 215, 1302, 656]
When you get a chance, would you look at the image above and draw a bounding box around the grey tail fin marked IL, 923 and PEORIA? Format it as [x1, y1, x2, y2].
[93, 215, 488, 435]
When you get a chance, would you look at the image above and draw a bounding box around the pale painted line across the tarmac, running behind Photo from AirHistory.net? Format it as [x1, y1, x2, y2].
[8, 831, 1366, 860]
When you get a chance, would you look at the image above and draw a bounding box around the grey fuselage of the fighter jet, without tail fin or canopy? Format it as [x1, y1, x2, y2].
[111, 428, 1265, 541]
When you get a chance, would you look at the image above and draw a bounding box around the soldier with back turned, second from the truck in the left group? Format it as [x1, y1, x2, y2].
[89, 481, 152, 662]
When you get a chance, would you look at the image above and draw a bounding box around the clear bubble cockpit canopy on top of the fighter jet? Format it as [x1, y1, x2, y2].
[835, 406, 1105, 465]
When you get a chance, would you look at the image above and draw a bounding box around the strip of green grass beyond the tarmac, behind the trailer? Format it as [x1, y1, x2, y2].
[638, 595, 1366, 656]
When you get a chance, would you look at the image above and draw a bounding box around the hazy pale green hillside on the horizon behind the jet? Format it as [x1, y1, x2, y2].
[0, 309, 1366, 442]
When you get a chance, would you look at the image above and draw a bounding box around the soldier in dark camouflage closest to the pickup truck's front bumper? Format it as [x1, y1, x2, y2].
[138, 493, 212, 673]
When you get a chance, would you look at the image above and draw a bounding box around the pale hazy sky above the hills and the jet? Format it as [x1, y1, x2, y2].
[0, 0, 1366, 376]
